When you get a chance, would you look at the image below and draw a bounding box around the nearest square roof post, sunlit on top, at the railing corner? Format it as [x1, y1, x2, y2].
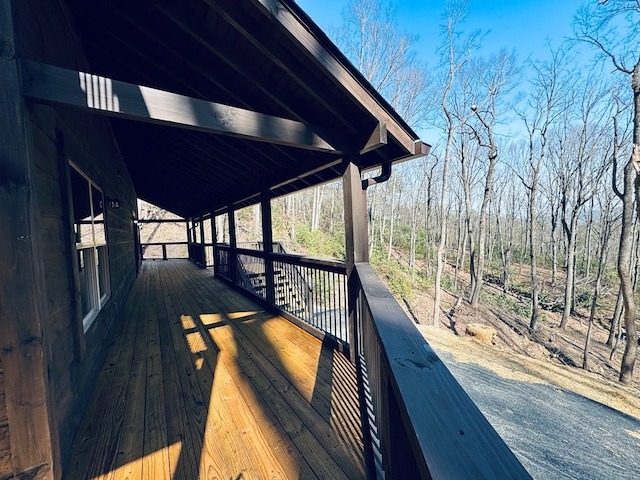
[342, 158, 369, 363]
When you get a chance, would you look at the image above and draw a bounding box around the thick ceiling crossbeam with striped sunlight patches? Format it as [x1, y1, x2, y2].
[20, 60, 339, 153]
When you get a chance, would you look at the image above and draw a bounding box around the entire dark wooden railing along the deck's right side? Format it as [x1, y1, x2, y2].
[143, 243, 531, 479]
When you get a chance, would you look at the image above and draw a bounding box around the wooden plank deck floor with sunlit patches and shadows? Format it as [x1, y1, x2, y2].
[64, 260, 365, 480]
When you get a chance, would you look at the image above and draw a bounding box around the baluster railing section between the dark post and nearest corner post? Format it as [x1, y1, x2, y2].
[214, 244, 350, 348]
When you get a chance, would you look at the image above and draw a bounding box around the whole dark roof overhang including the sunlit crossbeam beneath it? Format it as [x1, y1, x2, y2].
[22, 0, 428, 217]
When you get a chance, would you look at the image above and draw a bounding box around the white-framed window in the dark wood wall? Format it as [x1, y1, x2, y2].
[69, 164, 111, 332]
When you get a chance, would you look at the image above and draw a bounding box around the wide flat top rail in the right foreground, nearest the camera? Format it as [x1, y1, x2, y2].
[355, 263, 531, 478]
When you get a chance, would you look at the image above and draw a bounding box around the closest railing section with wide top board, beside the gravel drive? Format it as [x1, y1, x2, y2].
[350, 263, 531, 479]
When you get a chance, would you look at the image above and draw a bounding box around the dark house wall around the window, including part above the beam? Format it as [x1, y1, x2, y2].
[11, 0, 137, 466]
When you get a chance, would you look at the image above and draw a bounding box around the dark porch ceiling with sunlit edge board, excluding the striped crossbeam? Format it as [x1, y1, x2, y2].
[56, 0, 421, 217]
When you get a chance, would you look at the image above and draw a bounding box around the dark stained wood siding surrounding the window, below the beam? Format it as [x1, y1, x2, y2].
[30, 107, 136, 468]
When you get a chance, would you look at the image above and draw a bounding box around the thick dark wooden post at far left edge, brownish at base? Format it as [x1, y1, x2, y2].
[0, 0, 61, 479]
